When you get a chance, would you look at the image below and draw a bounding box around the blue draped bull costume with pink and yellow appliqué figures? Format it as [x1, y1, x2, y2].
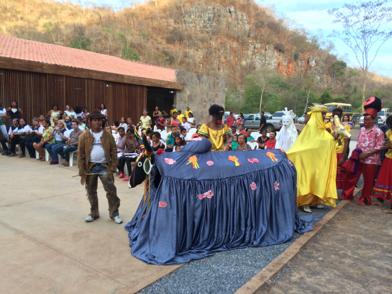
[126, 105, 311, 264]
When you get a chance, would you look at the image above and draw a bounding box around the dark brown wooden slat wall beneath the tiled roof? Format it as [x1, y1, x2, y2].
[0, 69, 147, 121]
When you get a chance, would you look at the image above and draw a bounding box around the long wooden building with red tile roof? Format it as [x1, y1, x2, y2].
[0, 36, 181, 121]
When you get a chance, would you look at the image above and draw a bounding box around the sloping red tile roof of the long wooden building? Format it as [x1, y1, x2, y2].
[0, 35, 176, 87]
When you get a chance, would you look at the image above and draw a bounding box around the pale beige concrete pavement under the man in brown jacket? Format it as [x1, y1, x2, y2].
[0, 156, 177, 294]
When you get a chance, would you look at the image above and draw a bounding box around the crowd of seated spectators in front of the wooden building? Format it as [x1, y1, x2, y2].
[0, 102, 282, 180]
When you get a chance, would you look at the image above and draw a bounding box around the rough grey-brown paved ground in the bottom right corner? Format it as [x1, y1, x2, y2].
[259, 203, 392, 294]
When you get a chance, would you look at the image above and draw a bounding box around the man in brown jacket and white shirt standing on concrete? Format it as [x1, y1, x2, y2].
[78, 111, 122, 224]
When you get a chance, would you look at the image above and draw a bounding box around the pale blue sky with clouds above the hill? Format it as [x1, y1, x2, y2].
[71, 0, 392, 77]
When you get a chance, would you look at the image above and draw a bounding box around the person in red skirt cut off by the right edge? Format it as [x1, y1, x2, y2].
[373, 115, 392, 208]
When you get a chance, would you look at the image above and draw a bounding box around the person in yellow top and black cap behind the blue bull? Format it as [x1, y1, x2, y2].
[197, 104, 231, 151]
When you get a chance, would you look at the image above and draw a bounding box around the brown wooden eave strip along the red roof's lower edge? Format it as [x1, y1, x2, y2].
[0, 56, 182, 90]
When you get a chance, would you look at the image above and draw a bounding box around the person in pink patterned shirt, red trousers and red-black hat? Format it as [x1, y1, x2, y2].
[342, 97, 385, 205]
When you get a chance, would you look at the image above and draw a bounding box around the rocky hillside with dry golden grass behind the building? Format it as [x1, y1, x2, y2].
[0, 0, 392, 111]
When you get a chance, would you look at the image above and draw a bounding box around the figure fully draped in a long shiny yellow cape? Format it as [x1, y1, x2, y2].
[287, 105, 338, 212]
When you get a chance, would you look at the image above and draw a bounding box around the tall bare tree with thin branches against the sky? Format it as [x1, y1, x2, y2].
[329, 0, 392, 100]
